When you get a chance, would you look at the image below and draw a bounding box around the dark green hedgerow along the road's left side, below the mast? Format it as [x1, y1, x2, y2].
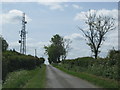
[2, 51, 45, 80]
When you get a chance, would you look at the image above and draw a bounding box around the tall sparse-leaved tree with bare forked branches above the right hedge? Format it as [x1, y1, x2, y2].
[78, 10, 115, 59]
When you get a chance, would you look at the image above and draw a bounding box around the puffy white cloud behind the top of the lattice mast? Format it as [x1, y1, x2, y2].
[0, 9, 32, 24]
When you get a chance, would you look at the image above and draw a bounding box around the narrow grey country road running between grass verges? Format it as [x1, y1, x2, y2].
[46, 65, 97, 88]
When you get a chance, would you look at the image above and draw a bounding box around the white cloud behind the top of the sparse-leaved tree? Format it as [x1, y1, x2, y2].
[74, 9, 118, 21]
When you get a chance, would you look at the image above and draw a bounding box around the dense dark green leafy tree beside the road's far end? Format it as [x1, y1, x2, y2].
[44, 34, 64, 63]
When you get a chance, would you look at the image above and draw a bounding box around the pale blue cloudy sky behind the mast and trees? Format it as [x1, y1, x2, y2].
[0, 2, 118, 63]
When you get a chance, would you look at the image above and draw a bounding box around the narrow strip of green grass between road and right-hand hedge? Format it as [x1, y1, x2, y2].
[53, 65, 118, 88]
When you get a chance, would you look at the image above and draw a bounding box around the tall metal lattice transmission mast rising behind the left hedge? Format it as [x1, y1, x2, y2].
[19, 13, 27, 54]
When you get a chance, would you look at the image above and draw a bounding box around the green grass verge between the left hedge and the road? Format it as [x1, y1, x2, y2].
[3, 65, 46, 88]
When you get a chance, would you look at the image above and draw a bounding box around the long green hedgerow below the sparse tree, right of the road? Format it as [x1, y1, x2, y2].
[61, 50, 120, 80]
